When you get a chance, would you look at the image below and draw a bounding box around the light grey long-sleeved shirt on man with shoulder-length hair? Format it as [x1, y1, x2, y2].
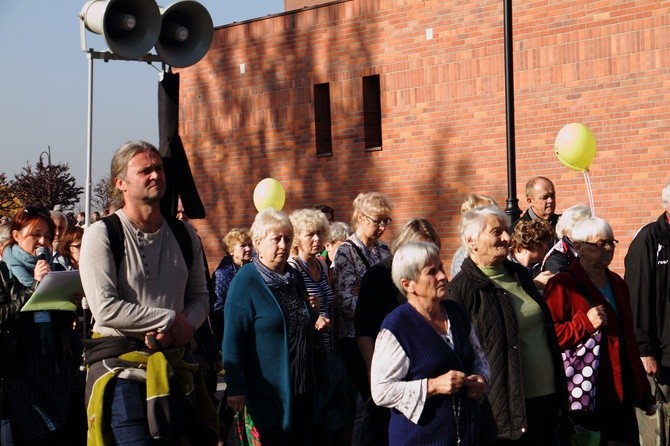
[79, 210, 209, 339]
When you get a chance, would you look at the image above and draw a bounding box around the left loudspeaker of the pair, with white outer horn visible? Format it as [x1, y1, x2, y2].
[79, 0, 161, 59]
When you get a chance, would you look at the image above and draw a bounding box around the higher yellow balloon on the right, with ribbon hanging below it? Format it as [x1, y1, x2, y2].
[554, 122, 596, 172]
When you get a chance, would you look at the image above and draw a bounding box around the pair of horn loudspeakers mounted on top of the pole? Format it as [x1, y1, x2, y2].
[79, 0, 214, 68]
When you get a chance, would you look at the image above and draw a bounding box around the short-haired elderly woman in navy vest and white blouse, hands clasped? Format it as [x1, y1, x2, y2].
[371, 242, 489, 445]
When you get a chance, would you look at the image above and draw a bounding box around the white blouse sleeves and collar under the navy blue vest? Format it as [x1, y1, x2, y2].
[370, 316, 491, 423]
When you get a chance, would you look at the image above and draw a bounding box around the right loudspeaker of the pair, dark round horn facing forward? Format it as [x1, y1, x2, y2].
[156, 0, 214, 68]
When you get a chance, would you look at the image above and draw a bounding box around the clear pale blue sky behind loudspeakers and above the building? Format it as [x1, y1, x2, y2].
[0, 0, 284, 207]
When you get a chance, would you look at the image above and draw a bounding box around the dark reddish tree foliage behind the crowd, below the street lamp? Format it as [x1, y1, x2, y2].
[10, 160, 84, 209]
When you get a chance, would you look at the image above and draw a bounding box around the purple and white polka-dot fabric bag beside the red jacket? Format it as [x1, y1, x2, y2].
[561, 330, 602, 412]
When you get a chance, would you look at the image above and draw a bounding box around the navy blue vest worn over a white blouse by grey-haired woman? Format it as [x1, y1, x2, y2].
[382, 300, 479, 446]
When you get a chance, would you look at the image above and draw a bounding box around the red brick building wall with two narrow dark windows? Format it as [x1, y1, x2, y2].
[180, 0, 670, 273]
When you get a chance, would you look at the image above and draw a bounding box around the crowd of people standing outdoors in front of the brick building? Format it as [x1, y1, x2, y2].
[0, 141, 670, 446]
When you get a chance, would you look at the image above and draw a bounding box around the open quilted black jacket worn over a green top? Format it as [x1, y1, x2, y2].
[449, 258, 567, 440]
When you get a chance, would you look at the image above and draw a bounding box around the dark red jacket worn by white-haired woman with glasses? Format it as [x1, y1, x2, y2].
[544, 258, 654, 408]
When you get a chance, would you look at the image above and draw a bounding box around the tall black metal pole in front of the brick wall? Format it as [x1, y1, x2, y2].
[503, 0, 521, 223]
